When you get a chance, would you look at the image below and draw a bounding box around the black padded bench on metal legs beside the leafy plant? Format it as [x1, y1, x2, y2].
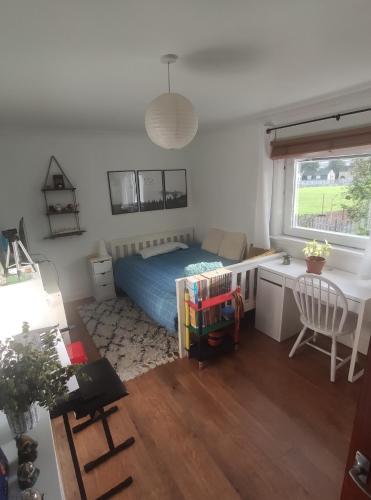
[50, 358, 135, 500]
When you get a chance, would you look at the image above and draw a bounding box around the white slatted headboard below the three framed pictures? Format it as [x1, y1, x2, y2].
[108, 227, 194, 261]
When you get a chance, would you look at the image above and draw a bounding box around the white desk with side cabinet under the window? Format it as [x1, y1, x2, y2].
[255, 258, 371, 382]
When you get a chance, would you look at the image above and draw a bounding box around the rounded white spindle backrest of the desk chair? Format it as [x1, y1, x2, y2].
[293, 273, 348, 335]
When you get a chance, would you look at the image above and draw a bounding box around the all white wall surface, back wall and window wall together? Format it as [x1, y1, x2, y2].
[0, 87, 371, 300]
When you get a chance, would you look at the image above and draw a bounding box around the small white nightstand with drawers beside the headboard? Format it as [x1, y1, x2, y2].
[89, 256, 116, 302]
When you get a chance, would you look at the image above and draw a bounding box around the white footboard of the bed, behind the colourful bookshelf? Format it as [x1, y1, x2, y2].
[175, 253, 283, 358]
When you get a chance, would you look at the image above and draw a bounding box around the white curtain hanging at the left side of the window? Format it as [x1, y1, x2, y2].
[253, 127, 273, 248]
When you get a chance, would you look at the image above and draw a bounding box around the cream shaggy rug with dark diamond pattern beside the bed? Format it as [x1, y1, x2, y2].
[79, 297, 178, 380]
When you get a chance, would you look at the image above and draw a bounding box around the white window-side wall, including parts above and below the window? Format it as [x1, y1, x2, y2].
[190, 89, 371, 270]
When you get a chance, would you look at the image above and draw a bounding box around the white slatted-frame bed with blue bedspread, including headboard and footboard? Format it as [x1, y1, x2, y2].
[109, 227, 283, 357]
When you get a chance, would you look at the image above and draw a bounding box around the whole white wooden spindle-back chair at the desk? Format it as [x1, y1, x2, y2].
[289, 273, 357, 382]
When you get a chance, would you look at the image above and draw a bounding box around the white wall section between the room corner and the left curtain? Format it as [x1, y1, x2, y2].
[189, 123, 259, 242]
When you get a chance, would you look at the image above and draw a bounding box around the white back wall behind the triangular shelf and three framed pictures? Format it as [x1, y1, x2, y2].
[0, 131, 194, 300]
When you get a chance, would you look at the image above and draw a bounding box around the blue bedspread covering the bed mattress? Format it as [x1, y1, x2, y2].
[114, 245, 235, 334]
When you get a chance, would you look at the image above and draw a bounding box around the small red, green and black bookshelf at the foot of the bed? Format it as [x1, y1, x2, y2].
[185, 288, 241, 368]
